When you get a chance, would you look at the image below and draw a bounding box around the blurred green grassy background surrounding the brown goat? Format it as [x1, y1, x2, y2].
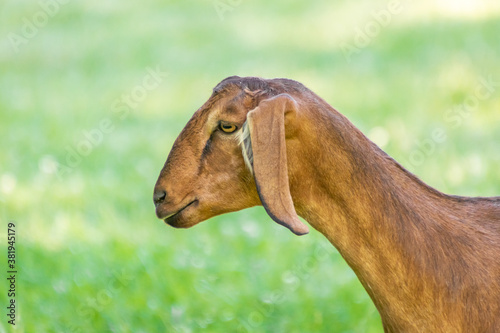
[0, 0, 500, 332]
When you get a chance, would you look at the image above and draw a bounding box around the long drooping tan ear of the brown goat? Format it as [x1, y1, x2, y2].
[247, 94, 309, 235]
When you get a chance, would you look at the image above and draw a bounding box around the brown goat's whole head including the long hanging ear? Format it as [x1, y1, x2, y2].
[153, 77, 307, 234]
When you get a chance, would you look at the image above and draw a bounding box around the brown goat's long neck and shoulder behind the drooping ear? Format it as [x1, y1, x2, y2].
[287, 95, 500, 332]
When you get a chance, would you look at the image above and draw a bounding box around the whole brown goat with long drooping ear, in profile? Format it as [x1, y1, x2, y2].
[153, 77, 500, 332]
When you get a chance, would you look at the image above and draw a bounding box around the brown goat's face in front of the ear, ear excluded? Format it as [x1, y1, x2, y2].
[154, 81, 259, 228]
